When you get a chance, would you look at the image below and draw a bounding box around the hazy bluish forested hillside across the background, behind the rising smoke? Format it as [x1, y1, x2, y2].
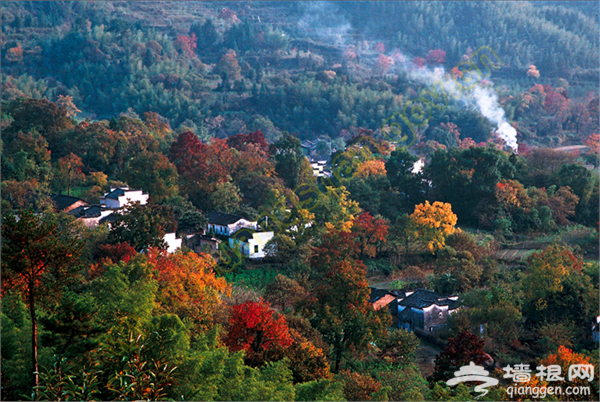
[2, 2, 599, 146]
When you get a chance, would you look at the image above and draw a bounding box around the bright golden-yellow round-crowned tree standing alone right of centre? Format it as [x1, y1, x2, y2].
[410, 201, 460, 253]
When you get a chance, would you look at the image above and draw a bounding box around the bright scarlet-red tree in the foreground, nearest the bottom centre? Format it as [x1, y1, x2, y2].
[225, 300, 292, 366]
